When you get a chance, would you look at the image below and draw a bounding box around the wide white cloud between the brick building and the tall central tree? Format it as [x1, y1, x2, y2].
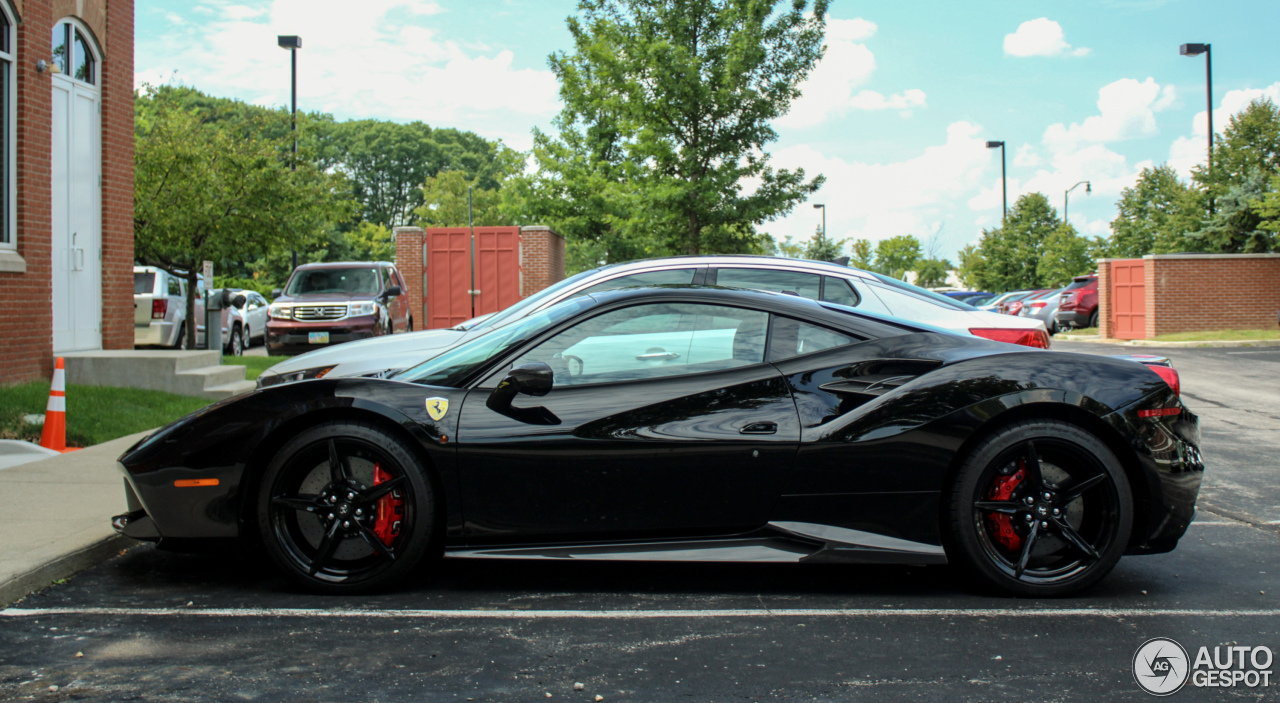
[134, 0, 559, 149]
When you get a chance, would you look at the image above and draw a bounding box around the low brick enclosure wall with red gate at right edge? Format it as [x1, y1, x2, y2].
[1098, 254, 1280, 339]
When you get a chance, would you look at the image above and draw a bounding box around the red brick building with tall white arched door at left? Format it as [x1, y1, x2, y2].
[0, 0, 133, 384]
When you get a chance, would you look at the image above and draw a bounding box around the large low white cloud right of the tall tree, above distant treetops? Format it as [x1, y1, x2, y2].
[762, 122, 1000, 249]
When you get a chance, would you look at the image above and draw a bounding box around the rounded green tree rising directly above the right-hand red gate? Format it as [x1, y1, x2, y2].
[1102, 164, 1204, 259]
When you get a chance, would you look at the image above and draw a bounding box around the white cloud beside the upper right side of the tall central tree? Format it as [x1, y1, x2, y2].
[777, 18, 925, 128]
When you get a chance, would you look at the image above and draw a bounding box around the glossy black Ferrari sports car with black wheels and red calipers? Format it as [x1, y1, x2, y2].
[114, 287, 1203, 595]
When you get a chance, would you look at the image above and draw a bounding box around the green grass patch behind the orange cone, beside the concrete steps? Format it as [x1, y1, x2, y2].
[0, 380, 211, 447]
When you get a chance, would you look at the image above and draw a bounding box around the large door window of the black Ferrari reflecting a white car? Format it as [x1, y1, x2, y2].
[516, 303, 769, 387]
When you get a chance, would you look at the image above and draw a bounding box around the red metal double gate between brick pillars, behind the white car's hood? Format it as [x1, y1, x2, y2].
[422, 227, 521, 329]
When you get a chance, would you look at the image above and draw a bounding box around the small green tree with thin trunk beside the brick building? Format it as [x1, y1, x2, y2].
[133, 91, 344, 347]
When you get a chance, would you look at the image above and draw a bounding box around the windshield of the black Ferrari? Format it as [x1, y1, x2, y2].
[393, 297, 595, 388]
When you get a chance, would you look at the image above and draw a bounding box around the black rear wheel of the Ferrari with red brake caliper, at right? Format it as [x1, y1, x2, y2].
[943, 420, 1134, 598]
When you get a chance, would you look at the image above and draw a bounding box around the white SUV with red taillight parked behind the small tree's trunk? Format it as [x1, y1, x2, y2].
[133, 266, 242, 353]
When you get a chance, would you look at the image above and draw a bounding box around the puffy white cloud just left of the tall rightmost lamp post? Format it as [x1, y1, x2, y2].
[1044, 78, 1178, 150]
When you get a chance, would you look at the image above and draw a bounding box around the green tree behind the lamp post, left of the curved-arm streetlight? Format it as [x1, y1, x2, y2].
[961, 193, 1062, 292]
